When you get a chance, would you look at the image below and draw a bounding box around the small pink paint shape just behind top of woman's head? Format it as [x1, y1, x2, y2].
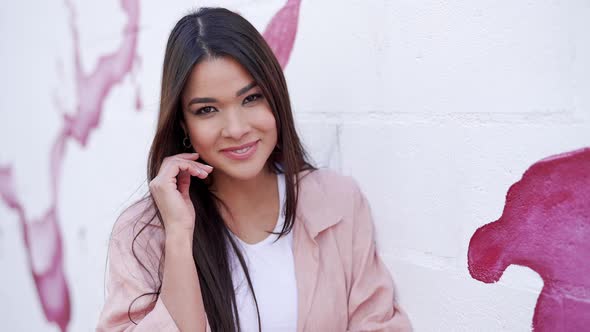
[263, 0, 301, 68]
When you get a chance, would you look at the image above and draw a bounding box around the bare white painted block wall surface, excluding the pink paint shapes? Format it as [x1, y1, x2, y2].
[0, 0, 590, 331]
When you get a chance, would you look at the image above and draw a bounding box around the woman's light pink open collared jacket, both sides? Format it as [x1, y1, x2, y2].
[97, 170, 411, 332]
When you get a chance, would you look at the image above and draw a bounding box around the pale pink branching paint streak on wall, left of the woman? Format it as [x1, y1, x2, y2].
[0, 0, 141, 331]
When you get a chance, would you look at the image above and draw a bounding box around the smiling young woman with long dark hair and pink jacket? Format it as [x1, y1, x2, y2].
[98, 8, 410, 331]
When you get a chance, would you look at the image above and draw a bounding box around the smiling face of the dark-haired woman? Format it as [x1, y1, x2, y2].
[181, 57, 277, 180]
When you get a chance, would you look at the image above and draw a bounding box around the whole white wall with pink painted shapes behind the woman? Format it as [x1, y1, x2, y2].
[0, 0, 590, 331]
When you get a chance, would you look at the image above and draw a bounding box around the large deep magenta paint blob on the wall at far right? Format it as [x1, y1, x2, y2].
[468, 148, 590, 331]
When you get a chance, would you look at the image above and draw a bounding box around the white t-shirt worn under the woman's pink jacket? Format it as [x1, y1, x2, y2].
[229, 174, 297, 332]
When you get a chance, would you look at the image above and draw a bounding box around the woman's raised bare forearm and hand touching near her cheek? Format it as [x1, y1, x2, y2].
[149, 153, 213, 332]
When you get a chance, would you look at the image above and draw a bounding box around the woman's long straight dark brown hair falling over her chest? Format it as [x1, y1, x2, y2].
[129, 8, 315, 331]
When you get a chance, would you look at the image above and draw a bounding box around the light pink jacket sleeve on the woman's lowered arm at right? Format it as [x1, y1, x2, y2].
[347, 185, 412, 332]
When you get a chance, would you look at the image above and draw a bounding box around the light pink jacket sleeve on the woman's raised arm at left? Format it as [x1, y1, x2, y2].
[96, 207, 179, 332]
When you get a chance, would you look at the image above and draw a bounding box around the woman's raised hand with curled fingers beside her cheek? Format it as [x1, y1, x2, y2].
[149, 153, 213, 236]
